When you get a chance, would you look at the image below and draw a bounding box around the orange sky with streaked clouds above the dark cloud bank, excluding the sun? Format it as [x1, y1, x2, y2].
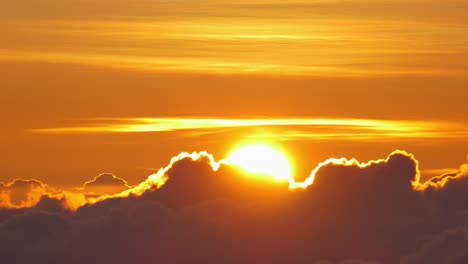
[0, 0, 468, 188]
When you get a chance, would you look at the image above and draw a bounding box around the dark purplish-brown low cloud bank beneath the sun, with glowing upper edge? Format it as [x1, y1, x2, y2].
[0, 151, 468, 264]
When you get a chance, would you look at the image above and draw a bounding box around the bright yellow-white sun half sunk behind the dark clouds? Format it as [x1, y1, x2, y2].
[225, 145, 292, 181]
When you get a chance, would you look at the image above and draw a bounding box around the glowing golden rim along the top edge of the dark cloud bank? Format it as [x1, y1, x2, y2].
[0, 150, 468, 210]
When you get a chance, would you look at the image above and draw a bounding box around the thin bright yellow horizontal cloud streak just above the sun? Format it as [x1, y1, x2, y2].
[30, 118, 467, 141]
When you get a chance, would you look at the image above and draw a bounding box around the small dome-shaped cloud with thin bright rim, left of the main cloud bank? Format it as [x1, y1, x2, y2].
[83, 173, 131, 195]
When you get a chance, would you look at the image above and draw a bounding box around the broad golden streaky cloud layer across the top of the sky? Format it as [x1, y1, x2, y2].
[0, 0, 468, 78]
